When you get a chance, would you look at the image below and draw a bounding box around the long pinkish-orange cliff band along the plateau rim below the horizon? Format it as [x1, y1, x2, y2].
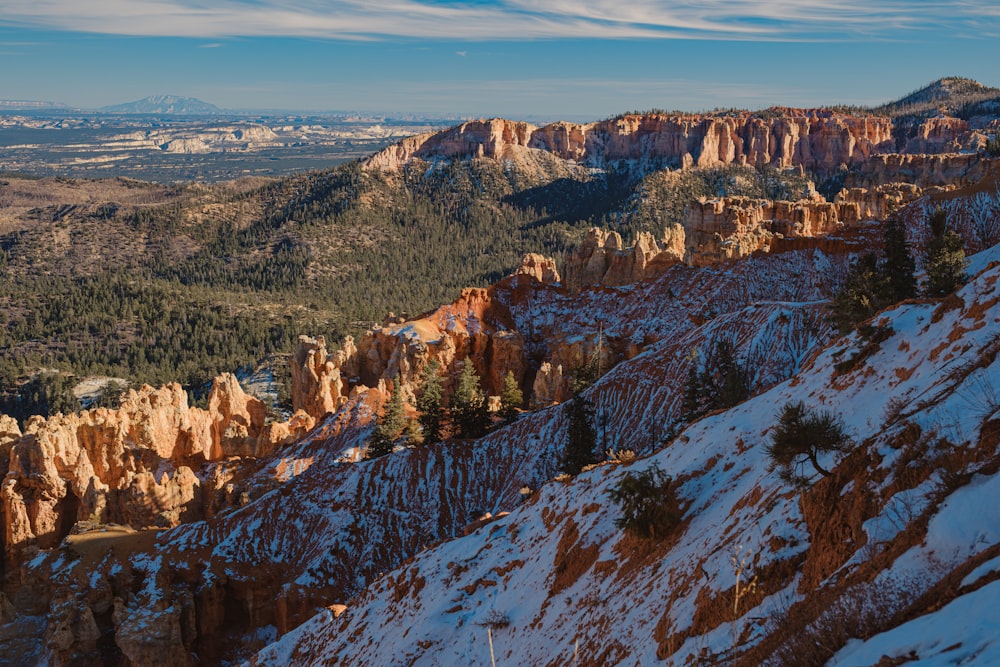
[366, 109, 979, 173]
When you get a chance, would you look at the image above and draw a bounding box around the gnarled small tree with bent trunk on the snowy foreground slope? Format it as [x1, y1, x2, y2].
[767, 401, 851, 486]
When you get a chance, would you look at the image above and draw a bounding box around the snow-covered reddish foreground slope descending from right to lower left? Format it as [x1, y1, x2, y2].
[255, 247, 1000, 665]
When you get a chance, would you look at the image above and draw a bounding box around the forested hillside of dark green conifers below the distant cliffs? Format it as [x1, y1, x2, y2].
[0, 159, 803, 419]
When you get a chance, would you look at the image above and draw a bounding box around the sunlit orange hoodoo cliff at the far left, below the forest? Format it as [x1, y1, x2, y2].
[0, 374, 312, 563]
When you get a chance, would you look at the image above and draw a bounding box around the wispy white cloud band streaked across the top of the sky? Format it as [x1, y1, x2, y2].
[0, 0, 988, 41]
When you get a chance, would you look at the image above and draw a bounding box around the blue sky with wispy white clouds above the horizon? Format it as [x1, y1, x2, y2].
[0, 0, 1000, 120]
